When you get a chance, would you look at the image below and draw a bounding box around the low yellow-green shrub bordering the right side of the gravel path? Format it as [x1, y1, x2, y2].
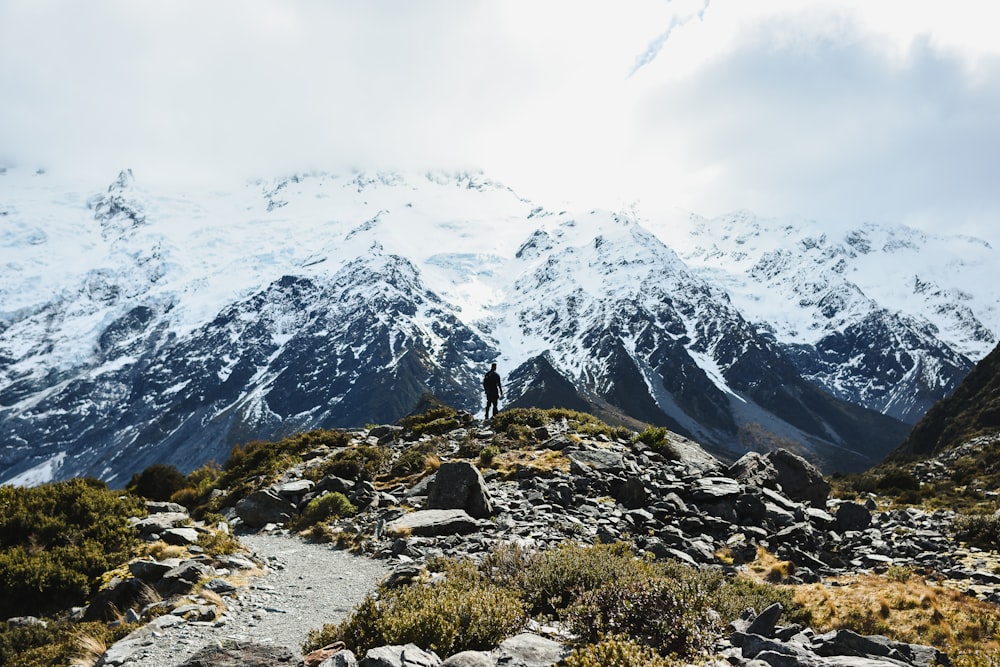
[302, 578, 525, 655]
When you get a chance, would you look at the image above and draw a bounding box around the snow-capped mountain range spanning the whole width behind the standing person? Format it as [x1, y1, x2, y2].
[0, 168, 997, 484]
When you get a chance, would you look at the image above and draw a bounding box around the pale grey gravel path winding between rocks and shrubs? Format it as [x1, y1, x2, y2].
[111, 535, 388, 667]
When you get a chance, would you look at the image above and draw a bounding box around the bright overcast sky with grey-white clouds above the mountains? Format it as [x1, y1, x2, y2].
[0, 0, 1000, 242]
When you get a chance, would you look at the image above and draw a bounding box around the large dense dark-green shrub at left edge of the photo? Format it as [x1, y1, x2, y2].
[0, 479, 143, 618]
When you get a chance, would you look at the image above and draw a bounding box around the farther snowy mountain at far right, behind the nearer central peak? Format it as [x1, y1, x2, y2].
[654, 212, 1000, 424]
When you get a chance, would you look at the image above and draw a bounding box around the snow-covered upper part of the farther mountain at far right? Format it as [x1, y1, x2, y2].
[649, 211, 1000, 359]
